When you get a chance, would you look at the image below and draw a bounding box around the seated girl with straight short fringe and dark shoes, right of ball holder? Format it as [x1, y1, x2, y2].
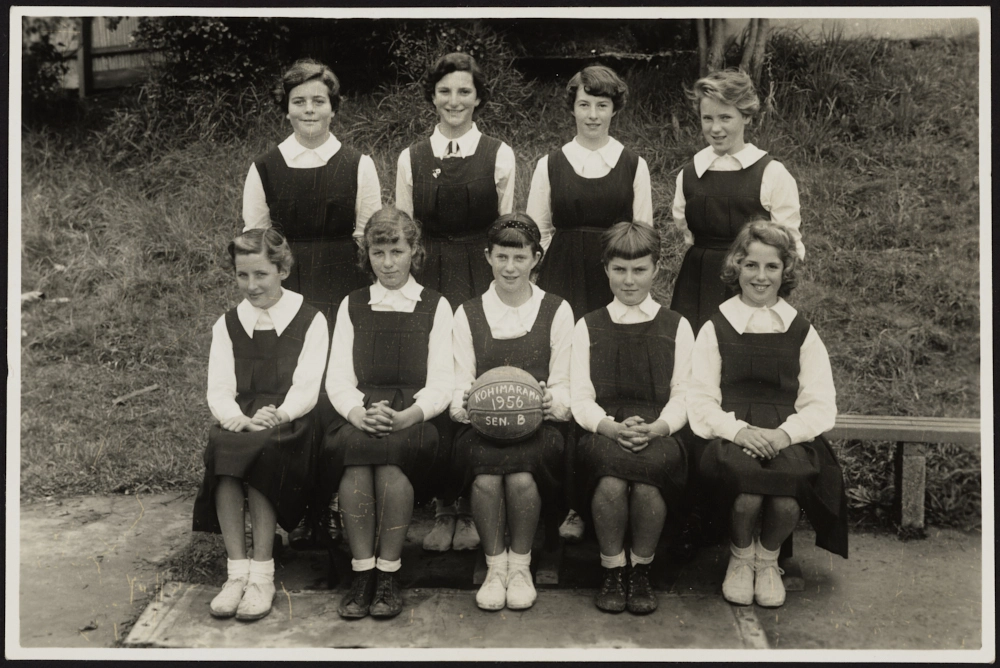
[570, 223, 694, 614]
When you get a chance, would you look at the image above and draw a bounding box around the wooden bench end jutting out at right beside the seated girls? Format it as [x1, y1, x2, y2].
[826, 415, 981, 529]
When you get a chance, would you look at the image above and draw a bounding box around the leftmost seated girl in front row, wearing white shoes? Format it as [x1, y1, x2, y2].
[193, 229, 329, 619]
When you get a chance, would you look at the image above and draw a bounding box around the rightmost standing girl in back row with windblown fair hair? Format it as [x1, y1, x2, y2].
[670, 70, 805, 332]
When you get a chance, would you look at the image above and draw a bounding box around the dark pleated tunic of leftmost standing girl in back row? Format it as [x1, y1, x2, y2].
[254, 146, 368, 331]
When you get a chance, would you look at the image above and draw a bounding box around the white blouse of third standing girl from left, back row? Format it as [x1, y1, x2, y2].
[527, 137, 653, 250]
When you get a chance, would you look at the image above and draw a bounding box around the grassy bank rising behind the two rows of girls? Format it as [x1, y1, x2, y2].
[21, 35, 980, 526]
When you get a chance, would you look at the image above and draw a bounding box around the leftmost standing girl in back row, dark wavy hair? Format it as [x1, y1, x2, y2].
[243, 59, 382, 322]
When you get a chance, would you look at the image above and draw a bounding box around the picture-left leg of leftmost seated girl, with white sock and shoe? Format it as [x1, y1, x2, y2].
[209, 476, 250, 618]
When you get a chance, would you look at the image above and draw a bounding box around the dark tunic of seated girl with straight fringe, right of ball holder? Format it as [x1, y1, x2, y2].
[575, 308, 687, 510]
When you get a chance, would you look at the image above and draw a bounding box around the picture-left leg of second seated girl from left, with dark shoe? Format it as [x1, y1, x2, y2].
[337, 466, 376, 619]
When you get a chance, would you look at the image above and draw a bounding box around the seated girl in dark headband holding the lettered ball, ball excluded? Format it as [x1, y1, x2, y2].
[451, 213, 573, 610]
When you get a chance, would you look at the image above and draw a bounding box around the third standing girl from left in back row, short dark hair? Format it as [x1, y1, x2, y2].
[527, 65, 653, 315]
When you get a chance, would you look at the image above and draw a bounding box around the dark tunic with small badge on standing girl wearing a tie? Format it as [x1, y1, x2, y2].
[410, 135, 501, 309]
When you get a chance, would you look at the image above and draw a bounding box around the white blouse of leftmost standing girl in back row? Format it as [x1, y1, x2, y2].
[243, 134, 382, 237]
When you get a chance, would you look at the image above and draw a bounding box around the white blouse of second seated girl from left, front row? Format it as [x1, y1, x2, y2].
[326, 275, 455, 420]
